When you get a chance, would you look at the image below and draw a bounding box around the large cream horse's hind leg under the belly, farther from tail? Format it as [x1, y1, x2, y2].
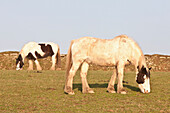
[80, 62, 94, 93]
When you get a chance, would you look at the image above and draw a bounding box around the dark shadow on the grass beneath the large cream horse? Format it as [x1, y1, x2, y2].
[73, 83, 140, 92]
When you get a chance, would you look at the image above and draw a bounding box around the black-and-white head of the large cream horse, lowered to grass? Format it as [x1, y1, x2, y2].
[136, 66, 151, 93]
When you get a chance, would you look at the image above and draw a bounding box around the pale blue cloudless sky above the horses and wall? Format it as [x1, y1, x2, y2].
[0, 0, 170, 55]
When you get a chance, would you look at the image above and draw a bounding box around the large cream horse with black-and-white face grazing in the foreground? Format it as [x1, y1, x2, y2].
[64, 35, 150, 95]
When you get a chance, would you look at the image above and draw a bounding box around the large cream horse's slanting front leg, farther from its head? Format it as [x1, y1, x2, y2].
[107, 66, 117, 93]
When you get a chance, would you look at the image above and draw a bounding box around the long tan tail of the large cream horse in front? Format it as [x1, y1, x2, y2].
[65, 41, 73, 88]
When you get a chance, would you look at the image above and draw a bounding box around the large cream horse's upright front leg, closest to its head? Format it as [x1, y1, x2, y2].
[117, 63, 126, 94]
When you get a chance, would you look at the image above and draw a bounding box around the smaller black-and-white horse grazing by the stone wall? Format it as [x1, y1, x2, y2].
[16, 42, 61, 70]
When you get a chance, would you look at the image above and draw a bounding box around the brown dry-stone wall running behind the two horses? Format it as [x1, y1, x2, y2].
[0, 51, 170, 71]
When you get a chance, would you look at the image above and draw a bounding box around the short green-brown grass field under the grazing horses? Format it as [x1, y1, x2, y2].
[0, 70, 170, 113]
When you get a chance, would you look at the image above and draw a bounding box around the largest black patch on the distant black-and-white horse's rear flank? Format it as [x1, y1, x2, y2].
[37, 44, 54, 58]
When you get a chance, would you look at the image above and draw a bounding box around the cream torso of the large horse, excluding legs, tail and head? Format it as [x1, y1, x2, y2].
[72, 35, 141, 65]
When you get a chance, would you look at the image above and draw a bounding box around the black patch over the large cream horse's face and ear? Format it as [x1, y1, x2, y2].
[136, 66, 150, 84]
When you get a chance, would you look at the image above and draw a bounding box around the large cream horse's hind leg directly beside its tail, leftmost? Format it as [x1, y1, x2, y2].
[64, 62, 81, 95]
